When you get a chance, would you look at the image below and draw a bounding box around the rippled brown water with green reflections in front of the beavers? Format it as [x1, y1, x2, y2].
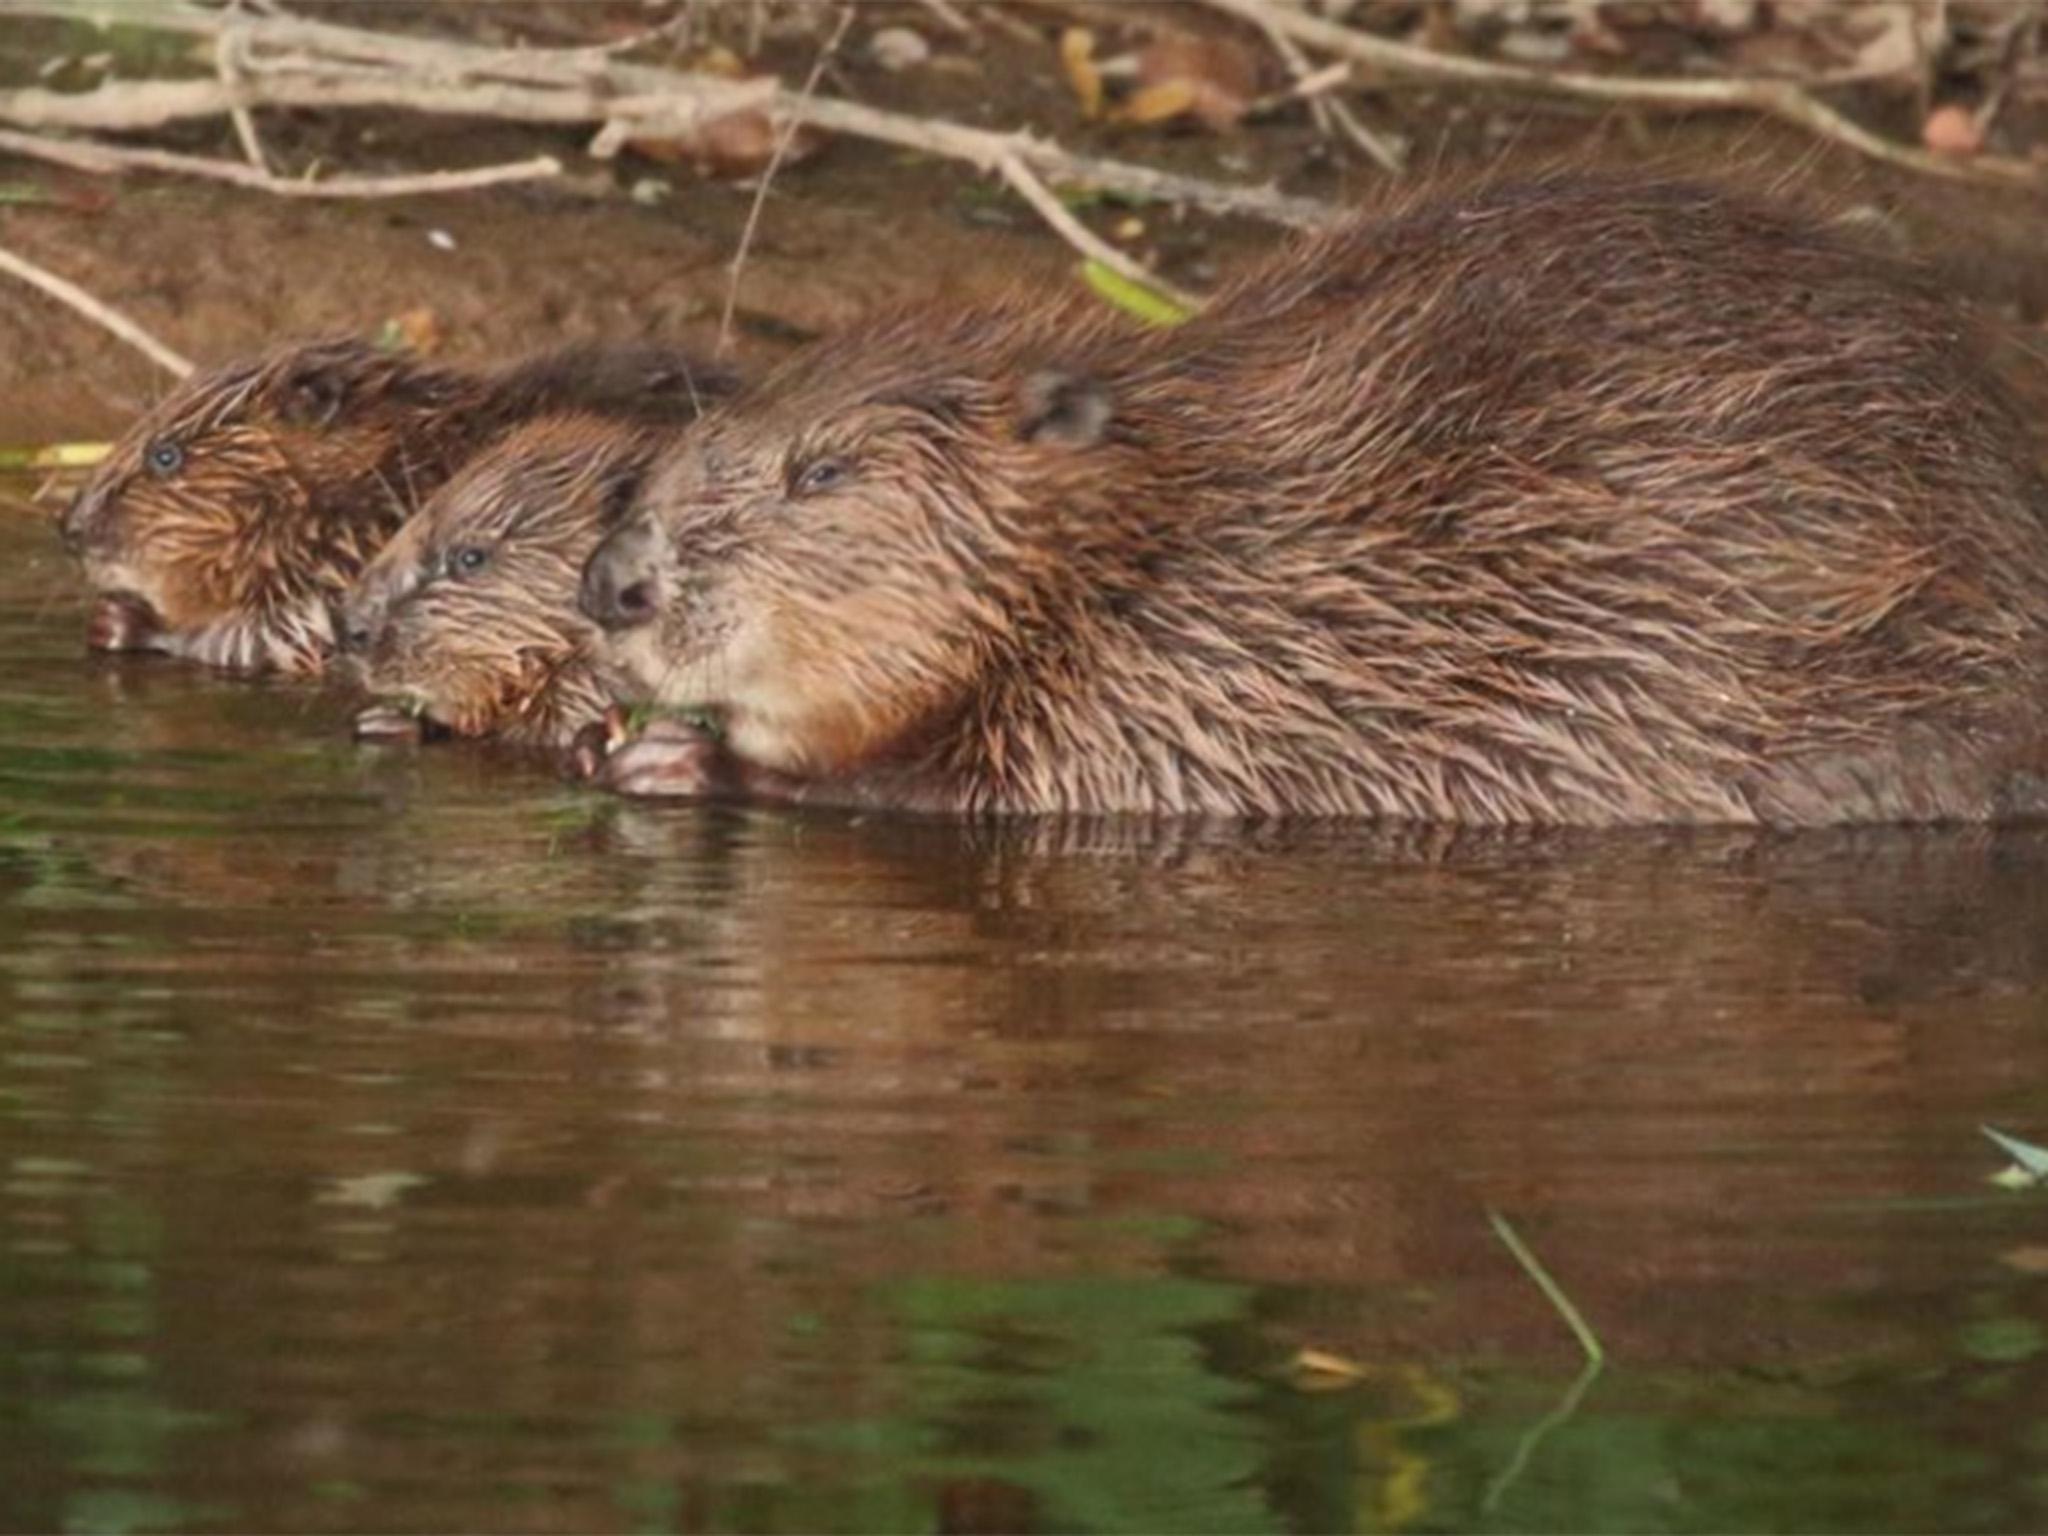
[0, 499, 2048, 1532]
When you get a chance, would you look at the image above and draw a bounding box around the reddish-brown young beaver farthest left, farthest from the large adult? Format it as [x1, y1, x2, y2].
[63, 340, 731, 672]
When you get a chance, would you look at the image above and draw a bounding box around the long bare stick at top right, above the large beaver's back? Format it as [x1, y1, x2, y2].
[1204, 0, 2042, 184]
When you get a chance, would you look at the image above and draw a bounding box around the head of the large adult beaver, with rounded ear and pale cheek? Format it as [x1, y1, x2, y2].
[582, 303, 1110, 772]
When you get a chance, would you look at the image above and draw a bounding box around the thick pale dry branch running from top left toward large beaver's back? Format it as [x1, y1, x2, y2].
[0, 0, 1333, 227]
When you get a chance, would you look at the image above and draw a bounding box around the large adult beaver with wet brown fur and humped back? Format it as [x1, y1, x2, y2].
[584, 176, 2048, 823]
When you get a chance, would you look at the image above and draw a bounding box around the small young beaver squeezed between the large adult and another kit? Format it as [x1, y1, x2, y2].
[338, 416, 657, 745]
